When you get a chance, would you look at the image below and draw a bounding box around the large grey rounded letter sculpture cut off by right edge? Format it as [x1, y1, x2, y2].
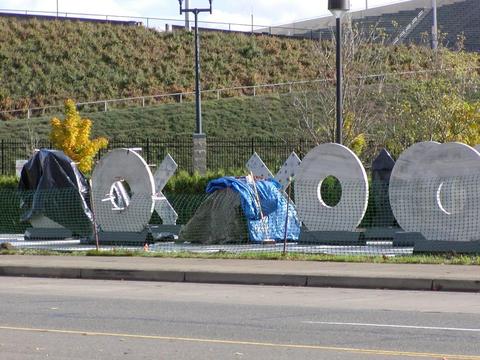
[389, 142, 480, 241]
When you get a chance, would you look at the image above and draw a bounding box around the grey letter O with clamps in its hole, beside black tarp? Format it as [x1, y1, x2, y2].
[92, 149, 155, 232]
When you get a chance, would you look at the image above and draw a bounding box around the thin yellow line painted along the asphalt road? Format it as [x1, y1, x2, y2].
[0, 326, 480, 360]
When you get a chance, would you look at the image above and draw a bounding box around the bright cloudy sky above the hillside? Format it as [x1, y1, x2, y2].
[0, 0, 412, 26]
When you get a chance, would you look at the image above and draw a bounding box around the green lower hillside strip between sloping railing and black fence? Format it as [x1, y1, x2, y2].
[0, 94, 297, 139]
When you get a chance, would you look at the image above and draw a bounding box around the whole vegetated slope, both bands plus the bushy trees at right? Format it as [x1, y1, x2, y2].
[0, 18, 480, 157]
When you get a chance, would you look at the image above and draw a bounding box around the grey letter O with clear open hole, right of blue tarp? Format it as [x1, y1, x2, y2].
[295, 143, 368, 231]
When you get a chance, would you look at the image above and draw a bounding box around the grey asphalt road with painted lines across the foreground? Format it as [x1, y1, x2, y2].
[0, 277, 480, 360]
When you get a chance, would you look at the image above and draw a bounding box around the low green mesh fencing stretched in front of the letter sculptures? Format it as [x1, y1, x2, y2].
[0, 176, 480, 256]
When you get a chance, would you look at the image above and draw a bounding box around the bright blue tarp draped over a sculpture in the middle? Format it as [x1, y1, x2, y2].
[206, 176, 300, 242]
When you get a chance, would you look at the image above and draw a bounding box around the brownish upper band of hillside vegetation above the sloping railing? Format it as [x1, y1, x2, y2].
[0, 17, 478, 114]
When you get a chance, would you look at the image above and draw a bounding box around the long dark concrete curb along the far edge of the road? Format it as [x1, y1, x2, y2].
[0, 266, 480, 292]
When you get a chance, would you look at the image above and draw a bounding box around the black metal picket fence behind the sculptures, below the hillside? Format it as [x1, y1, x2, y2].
[0, 135, 315, 175]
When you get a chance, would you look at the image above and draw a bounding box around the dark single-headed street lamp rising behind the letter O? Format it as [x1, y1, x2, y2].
[328, 0, 350, 144]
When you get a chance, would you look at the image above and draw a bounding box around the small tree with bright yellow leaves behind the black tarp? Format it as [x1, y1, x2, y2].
[50, 99, 108, 173]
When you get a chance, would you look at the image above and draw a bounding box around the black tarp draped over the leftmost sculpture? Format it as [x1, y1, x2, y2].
[18, 149, 93, 235]
